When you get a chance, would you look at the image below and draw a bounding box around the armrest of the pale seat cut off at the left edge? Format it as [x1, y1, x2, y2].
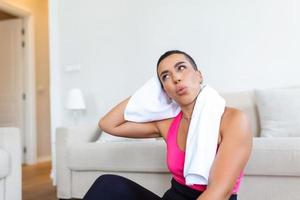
[0, 127, 22, 200]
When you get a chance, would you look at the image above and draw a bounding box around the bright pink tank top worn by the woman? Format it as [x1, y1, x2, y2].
[167, 112, 243, 194]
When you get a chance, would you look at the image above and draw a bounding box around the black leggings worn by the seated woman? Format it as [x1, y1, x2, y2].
[83, 174, 237, 200]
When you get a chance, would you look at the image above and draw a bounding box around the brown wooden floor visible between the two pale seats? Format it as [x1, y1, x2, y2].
[22, 162, 57, 200]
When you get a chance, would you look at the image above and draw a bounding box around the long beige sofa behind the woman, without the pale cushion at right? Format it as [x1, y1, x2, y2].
[56, 91, 300, 200]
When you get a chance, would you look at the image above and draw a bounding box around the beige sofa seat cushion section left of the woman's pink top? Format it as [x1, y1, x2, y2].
[66, 140, 168, 172]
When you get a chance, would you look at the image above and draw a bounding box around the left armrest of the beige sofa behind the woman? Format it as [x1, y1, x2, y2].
[55, 125, 102, 199]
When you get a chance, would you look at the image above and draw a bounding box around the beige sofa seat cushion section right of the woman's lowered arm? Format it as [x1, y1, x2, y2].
[245, 137, 300, 177]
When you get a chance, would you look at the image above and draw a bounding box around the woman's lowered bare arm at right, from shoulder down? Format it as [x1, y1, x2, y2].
[197, 108, 252, 200]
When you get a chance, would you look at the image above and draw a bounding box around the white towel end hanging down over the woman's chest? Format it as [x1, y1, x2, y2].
[183, 85, 225, 185]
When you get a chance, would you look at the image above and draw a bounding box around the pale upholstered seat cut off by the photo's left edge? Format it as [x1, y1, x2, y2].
[0, 127, 21, 200]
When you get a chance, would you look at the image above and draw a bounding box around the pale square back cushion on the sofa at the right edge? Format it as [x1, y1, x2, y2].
[255, 88, 300, 137]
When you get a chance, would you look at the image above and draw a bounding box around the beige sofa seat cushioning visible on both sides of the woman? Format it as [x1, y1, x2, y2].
[66, 137, 300, 176]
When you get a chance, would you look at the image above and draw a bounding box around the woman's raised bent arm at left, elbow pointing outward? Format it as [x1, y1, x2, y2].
[98, 97, 160, 138]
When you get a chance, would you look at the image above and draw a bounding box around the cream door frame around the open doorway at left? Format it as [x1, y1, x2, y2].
[0, 0, 37, 164]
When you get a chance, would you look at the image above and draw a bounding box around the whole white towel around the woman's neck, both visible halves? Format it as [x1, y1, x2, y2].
[124, 76, 225, 185]
